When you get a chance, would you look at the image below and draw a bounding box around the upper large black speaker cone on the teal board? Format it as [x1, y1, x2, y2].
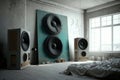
[42, 14, 61, 34]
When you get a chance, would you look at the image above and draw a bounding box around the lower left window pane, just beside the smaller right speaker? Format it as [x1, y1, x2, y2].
[89, 28, 100, 51]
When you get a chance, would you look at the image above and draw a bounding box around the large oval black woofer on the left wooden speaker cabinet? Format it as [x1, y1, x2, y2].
[21, 31, 30, 51]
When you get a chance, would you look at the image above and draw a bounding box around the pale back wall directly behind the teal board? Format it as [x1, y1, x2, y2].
[25, 0, 84, 60]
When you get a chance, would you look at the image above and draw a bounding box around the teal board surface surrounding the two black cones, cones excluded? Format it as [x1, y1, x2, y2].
[36, 10, 69, 64]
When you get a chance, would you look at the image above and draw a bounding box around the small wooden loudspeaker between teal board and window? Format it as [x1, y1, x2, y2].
[74, 38, 88, 61]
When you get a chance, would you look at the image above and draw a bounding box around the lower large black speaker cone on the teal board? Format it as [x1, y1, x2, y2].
[44, 36, 63, 58]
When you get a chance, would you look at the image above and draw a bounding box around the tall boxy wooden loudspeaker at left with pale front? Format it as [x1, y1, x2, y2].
[8, 28, 30, 69]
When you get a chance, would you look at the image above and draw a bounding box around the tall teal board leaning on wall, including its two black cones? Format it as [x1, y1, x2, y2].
[37, 10, 69, 64]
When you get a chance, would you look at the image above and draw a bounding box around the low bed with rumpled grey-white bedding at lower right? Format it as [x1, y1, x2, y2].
[64, 58, 120, 80]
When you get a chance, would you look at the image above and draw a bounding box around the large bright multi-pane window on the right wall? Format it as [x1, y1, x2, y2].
[89, 14, 120, 52]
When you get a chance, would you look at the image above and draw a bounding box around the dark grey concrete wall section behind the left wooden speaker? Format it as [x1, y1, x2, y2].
[0, 0, 25, 62]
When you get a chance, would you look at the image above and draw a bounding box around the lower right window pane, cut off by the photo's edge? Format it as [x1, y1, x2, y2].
[113, 26, 120, 51]
